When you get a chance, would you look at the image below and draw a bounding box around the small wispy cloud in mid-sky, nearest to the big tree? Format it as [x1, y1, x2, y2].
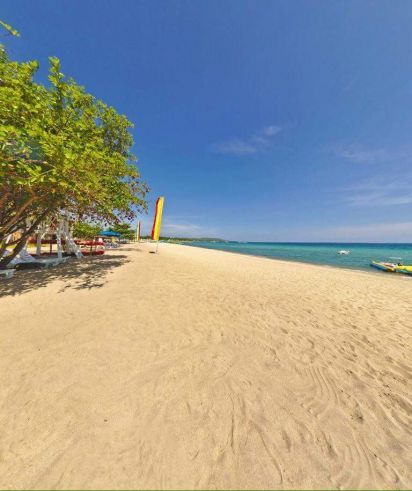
[212, 125, 282, 155]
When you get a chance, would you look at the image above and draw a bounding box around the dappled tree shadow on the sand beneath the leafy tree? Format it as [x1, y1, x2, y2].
[0, 253, 130, 298]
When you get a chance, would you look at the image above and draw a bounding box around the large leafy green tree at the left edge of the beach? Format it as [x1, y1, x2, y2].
[0, 40, 147, 267]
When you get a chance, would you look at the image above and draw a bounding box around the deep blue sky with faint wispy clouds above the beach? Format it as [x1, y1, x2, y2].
[0, 0, 412, 242]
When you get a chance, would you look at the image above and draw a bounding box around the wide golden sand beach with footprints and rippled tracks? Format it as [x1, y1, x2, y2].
[0, 244, 412, 489]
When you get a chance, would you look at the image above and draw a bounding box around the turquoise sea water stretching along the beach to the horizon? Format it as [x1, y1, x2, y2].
[185, 241, 412, 274]
